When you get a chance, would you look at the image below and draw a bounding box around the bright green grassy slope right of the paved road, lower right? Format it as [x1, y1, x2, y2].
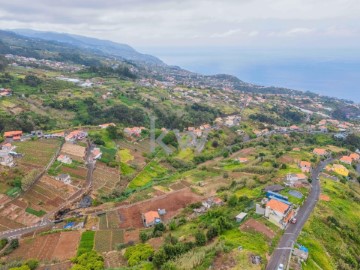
[298, 179, 360, 270]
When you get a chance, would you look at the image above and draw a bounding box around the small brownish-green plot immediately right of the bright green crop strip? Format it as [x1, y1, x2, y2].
[94, 229, 124, 253]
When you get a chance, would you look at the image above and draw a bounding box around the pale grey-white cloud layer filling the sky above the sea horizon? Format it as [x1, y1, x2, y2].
[0, 0, 360, 46]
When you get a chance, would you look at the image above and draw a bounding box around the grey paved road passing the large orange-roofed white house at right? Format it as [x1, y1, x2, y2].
[266, 159, 333, 270]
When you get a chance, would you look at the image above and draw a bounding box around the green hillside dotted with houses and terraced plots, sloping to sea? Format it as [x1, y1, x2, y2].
[0, 31, 360, 270]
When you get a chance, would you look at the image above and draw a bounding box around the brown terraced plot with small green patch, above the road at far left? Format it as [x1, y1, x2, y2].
[0, 176, 77, 228]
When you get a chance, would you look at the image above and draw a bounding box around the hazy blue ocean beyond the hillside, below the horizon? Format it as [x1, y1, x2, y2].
[142, 47, 360, 103]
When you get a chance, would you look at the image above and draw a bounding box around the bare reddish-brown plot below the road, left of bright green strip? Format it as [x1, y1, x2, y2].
[8, 231, 80, 262]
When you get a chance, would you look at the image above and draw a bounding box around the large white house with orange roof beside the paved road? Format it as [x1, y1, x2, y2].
[265, 198, 295, 229]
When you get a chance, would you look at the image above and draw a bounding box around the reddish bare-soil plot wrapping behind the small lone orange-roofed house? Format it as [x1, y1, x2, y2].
[118, 188, 203, 228]
